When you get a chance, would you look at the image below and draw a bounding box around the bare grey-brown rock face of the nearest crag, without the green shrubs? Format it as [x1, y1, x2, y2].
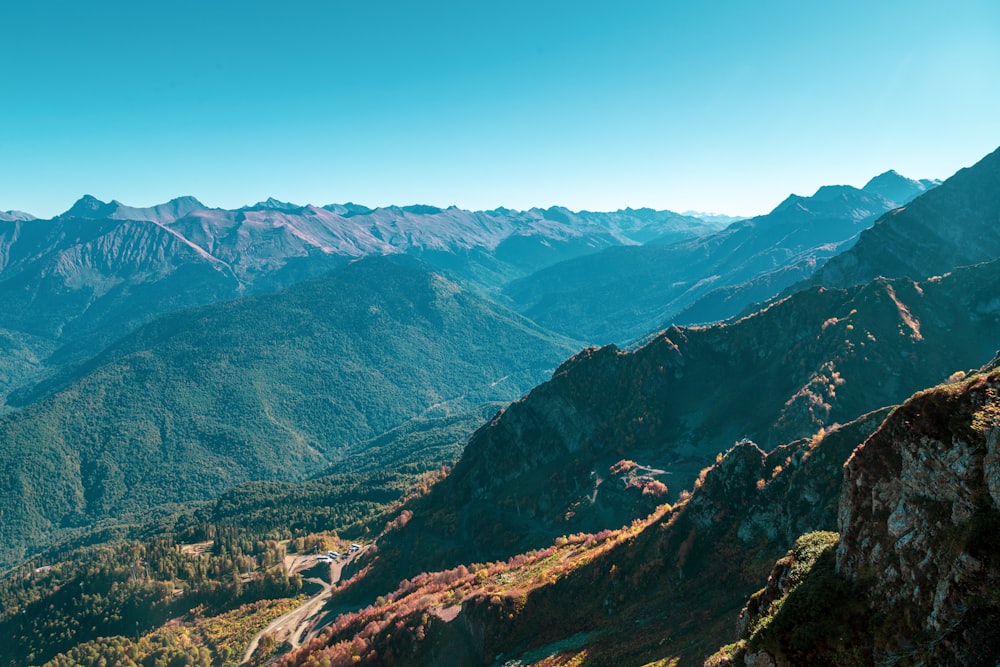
[837, 371, 1000, 665]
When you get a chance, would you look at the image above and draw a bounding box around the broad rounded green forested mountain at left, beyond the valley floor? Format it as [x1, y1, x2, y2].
[0, 257, 574, 562]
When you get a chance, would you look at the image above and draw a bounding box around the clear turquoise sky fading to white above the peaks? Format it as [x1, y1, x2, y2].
[0, 0, 1000, 217]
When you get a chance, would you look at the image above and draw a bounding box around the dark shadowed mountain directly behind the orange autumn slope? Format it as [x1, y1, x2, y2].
[364, 262, 1000, 581]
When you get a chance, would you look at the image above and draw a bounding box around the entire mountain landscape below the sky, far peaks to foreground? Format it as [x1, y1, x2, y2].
[0, 146, 1000, 667]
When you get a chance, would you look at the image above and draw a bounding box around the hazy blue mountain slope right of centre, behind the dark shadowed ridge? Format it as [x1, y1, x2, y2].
[504, 174, 924, 343]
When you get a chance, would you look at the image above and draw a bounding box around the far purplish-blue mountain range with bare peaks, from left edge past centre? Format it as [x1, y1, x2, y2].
[0, 196, 716, 396]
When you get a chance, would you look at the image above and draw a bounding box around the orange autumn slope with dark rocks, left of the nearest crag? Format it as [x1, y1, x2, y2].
[286, 412, 885, 667]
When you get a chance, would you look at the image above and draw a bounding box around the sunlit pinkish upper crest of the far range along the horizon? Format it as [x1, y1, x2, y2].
[48, 195, 721, 268]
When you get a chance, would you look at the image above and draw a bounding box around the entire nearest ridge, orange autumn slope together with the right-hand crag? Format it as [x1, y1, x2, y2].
[280, 370, 1000, 667]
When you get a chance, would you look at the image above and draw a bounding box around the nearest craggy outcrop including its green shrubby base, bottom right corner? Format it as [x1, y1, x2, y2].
[706, 370, 1000, 667]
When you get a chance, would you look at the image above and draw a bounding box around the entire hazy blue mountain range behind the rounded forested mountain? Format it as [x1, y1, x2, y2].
[0, 172, 935, 408]
